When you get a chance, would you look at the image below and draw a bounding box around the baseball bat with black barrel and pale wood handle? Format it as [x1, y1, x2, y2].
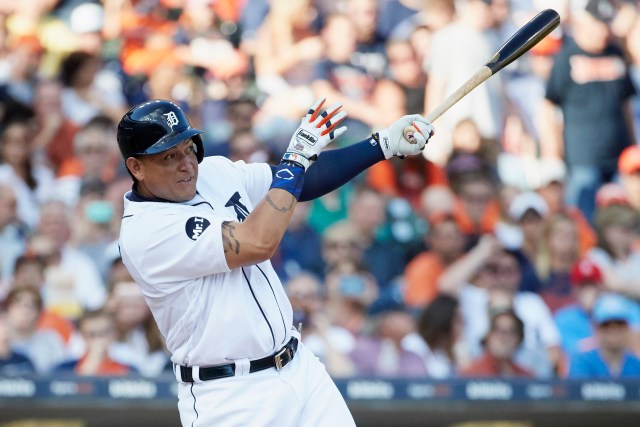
[404, 9, 560, 141]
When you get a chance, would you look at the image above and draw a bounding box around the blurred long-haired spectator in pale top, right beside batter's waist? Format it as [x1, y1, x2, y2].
[104, 280, 169, 377]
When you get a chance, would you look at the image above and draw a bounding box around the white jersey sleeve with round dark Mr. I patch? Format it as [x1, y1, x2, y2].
[120, 206, 230, 291]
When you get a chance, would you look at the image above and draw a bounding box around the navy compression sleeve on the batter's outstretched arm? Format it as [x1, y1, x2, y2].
[271, 139, 384, 202]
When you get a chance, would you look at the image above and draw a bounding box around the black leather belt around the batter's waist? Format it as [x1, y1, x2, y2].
[176, 337, 298, 383]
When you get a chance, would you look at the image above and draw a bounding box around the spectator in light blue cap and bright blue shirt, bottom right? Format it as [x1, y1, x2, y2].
[568, 294, 640, 378]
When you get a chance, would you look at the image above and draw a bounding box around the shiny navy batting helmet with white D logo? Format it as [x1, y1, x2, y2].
[118, 99, 204, 163]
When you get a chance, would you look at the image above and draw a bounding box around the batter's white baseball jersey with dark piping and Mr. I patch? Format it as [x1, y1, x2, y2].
[119, 156, 292, 366]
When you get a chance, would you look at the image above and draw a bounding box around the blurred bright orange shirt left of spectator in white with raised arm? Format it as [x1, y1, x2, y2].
[404, 252, 445, 307]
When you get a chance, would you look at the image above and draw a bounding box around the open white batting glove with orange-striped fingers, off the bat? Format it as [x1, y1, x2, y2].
[282, 98, 347, 169]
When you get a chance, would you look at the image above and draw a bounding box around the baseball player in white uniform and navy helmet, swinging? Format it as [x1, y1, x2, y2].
[117, 100, 433, 427]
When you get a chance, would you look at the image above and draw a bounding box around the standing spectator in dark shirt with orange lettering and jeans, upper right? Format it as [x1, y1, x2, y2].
[542, 0, 635, 226]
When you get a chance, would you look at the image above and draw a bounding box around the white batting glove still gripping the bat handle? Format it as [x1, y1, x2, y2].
[373, 114, 435, 159]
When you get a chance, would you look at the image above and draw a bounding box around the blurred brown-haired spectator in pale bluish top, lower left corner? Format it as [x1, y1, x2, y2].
[5, 287, 66, 374]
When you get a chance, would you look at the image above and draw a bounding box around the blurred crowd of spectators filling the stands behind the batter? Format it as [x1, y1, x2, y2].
[0, 0, 640, 379]
